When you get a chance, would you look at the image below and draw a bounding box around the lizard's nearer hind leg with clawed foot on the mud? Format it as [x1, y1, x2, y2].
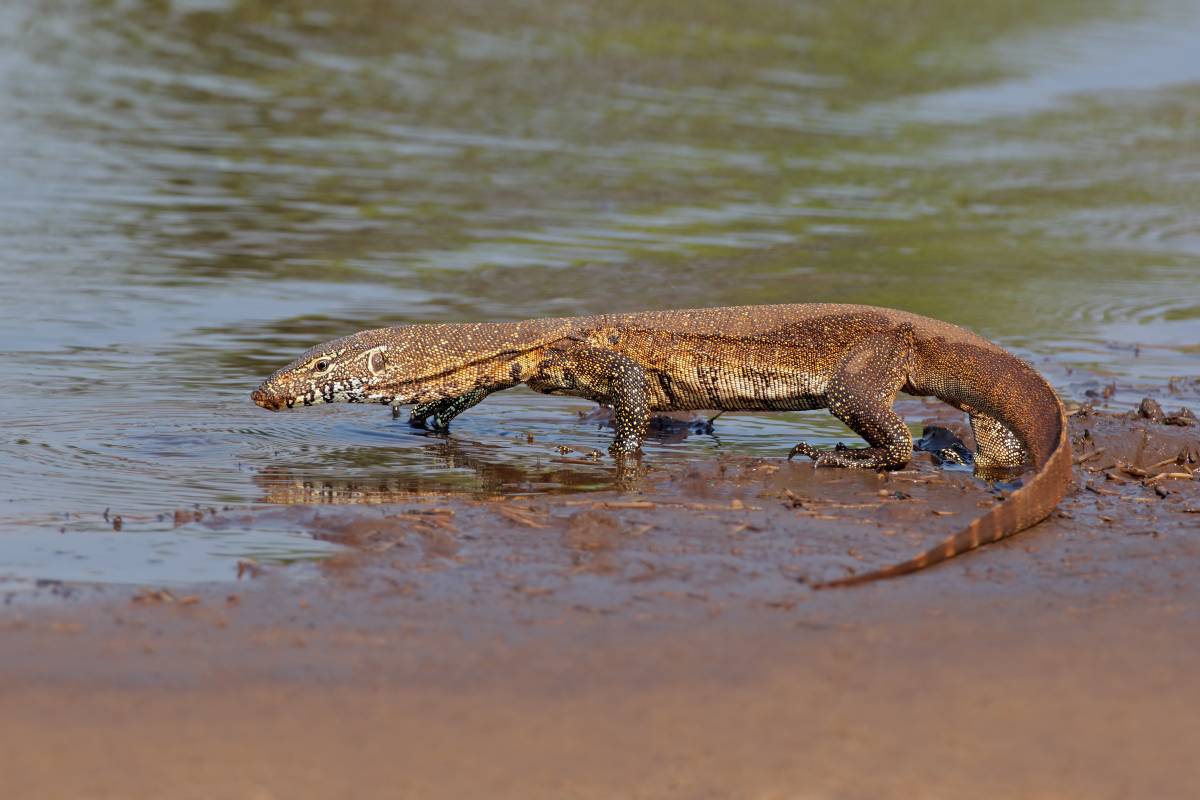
[788, 327, 912, 469]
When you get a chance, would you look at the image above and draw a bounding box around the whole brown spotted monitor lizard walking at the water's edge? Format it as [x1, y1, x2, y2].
[252, 303, 1072, 588]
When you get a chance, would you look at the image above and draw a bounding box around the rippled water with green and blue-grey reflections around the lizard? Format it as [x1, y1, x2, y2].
[0, 0, 1200, 582]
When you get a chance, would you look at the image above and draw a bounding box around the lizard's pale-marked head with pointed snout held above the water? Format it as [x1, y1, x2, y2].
[250, 331, 404, 411]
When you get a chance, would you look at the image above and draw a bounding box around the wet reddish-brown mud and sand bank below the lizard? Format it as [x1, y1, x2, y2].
[0, 415, 1200, 800]
